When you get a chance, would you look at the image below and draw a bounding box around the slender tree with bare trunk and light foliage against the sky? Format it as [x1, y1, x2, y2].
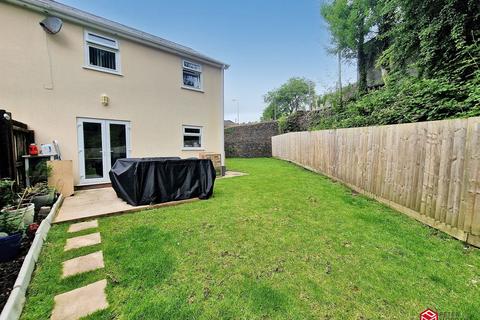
[321, 0, 378, 94]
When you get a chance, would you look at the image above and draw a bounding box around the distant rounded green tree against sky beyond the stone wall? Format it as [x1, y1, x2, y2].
[262, 78, 315, 120]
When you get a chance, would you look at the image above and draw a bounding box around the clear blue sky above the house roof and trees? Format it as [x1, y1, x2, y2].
[57, 0, 356, 122]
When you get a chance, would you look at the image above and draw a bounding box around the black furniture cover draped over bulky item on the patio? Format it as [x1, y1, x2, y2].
[109, 157, 216, 206]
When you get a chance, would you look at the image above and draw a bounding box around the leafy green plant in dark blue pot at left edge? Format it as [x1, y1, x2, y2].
[0, 179, 30, 261]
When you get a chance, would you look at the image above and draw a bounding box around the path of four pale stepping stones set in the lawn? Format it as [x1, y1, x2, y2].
[50, 220, 108, 320]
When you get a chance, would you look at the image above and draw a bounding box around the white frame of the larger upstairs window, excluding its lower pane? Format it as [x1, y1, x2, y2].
[83, 30, 122, 75]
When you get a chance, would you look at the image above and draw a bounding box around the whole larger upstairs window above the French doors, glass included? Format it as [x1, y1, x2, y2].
[85, 31, 120, 74]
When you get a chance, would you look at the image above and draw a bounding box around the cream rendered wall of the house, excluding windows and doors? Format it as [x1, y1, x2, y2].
[0, 2, 224, 184]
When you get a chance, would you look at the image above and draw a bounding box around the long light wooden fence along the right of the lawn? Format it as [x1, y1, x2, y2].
[272, 117, 480, 246]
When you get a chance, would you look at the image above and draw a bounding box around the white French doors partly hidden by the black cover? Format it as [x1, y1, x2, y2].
[77, 118, 131, 184]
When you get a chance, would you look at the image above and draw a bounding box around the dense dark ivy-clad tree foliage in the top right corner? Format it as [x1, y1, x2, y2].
[381, 0, 480, 81]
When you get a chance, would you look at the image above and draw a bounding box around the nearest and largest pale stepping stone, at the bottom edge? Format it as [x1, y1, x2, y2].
[50, 279, 108, 320]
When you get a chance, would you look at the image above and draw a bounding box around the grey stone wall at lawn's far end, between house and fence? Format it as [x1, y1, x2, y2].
[225, 121, 278, 158]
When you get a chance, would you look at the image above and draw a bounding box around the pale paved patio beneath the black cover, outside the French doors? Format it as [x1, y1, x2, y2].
[53, 187, 198, 223]
